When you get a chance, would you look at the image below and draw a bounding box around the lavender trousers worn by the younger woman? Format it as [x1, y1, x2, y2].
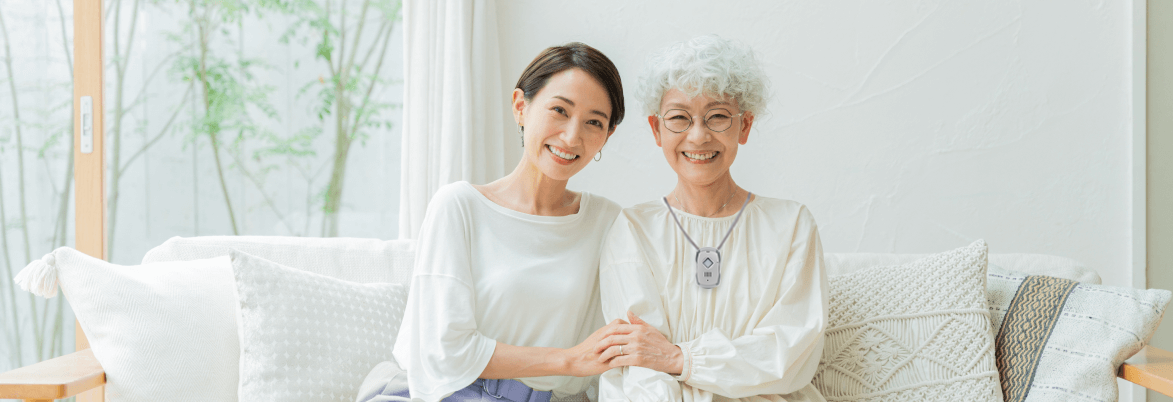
[357, 361, 554, 402]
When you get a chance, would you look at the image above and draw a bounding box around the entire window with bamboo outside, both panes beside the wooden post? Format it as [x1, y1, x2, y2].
[0, 0, 404, 372]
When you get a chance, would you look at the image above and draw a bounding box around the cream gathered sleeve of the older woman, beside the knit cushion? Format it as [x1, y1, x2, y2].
[678, 207, 829, 397]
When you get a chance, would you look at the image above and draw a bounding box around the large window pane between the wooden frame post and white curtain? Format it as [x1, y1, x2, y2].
[104, 0, 402, 264]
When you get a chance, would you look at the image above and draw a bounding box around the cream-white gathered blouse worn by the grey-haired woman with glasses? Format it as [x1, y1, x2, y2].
[599, 196, 828, 402]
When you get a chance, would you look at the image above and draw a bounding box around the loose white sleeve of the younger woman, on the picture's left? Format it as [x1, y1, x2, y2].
[394, 186, 496, 402]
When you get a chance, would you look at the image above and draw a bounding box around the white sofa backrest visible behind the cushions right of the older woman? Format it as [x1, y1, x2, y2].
[823, 253, 1100, 285]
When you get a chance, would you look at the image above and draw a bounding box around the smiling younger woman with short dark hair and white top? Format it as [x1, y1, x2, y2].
[359, 43, 630, 402]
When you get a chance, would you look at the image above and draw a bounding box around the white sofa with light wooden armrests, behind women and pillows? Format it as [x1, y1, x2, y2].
[0, 237, 1173, 400]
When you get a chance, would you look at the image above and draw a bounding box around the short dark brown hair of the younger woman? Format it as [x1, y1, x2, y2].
[514, 42, 623, 130]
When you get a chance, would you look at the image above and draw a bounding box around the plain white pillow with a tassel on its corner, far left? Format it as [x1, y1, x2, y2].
[16, 247, 239, 402]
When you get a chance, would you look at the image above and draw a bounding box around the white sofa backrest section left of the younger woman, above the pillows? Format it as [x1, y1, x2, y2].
[143, 236, 415, 284]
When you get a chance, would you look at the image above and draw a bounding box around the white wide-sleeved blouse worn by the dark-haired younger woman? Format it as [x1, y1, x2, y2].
[394, 182, 619, 402]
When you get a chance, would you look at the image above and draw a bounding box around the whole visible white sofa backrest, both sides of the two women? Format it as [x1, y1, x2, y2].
[143, 236, 1100, 284]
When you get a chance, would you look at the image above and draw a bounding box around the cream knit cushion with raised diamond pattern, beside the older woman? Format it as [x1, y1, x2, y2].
[813, 240, 1002, 402]
